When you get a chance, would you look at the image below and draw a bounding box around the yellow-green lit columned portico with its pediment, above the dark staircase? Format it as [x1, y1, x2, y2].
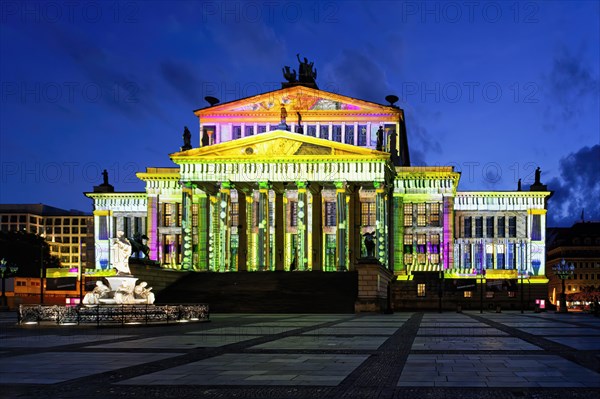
[166, 130, 395, 271]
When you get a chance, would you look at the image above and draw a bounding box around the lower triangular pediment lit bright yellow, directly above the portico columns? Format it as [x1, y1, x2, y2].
[171, 130, 389, 164]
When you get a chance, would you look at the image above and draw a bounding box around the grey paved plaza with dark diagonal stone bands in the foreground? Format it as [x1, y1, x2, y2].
[0, 312, 600, 399]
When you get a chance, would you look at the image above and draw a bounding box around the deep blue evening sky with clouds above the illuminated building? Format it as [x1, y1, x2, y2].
[0, 0, 600, 225]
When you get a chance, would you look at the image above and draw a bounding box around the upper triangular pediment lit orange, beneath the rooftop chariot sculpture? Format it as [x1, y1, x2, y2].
[195, 86, 399, 118]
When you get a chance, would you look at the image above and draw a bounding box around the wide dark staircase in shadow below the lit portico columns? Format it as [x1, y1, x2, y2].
[156, 272, 358, 313]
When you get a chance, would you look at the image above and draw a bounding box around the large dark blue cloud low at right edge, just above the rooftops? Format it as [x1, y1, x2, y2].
[546, 144, 600, 226]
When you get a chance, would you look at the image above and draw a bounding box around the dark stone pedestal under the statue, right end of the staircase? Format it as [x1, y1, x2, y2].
[354, 258, 394, 313]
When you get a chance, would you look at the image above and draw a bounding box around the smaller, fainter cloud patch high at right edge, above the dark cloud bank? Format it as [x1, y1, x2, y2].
[544, 47, 600, 130]
